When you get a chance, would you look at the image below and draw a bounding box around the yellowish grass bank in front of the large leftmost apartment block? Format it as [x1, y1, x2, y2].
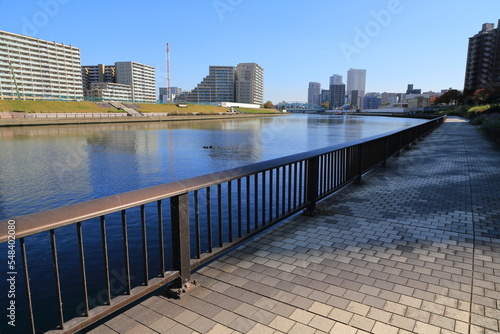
[0, 100, 120, 113]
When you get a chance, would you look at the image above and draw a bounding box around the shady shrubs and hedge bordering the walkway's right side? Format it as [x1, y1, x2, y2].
[443, 104, 500, 146]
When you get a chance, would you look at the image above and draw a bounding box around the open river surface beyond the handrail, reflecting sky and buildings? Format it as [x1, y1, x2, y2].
[0, 115, 422, 219]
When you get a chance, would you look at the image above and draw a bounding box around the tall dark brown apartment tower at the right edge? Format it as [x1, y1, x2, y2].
[464, 20, 500, 92]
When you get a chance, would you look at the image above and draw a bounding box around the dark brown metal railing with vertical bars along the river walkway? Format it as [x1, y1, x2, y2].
[0, 117, 444, 333]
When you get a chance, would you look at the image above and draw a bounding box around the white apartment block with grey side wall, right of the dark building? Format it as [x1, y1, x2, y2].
[115, 61, 156, 103]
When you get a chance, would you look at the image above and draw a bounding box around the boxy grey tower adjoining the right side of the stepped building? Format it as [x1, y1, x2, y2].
[235, 63, 264, 104]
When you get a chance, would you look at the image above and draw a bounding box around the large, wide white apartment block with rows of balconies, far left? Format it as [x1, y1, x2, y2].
[0, 31, 83, 101]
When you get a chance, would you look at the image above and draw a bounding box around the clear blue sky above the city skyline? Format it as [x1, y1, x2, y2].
[0, 0, 500, 103]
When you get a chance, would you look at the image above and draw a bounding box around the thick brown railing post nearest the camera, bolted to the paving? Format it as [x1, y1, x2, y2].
[169, 194, 197, 298]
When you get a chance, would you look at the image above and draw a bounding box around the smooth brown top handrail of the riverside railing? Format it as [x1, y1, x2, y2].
[0, 117, 443, 243]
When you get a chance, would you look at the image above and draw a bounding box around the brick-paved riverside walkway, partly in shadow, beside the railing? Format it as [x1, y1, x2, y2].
[92, 118, 500, 334]
